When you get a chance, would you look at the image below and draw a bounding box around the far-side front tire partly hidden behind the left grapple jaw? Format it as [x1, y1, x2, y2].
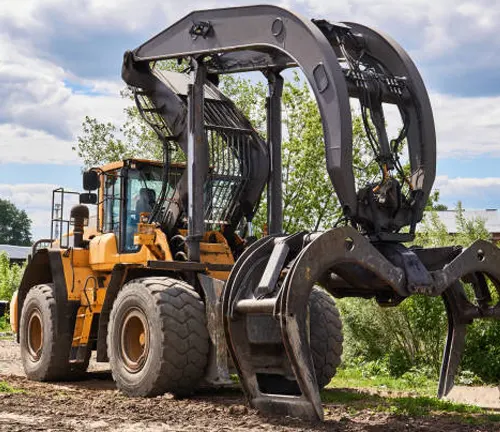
[309, 287, 344, 390]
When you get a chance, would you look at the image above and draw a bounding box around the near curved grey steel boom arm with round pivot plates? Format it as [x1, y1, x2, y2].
[124, 6, 357, 219]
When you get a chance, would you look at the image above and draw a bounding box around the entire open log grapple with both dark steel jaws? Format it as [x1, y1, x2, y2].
[223, 227, 500, 420]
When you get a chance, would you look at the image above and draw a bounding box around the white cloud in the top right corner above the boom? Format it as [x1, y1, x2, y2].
[287, 0, 500, 59]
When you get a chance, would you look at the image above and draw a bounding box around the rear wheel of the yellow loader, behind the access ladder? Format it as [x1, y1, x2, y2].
[19, 284, 88, 381]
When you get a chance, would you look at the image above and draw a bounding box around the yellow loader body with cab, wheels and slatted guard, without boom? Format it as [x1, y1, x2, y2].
[11, 57, 342, 396]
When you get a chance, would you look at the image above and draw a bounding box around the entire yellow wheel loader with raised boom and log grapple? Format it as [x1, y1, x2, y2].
[11, 6, 500, 420]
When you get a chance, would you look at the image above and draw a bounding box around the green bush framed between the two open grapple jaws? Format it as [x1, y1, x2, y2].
[337, 296, 447, 377]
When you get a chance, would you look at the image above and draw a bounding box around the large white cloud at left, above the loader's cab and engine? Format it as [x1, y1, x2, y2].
[0, 34, 128, 164]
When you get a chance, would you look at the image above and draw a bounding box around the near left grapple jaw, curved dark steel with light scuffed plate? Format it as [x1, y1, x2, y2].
[223, 227, 404, 420]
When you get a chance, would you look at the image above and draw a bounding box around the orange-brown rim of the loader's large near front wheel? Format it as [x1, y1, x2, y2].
[120, 308, 149, 373]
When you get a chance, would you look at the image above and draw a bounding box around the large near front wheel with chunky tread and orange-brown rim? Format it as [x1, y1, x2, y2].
[107, 277, 209, 397]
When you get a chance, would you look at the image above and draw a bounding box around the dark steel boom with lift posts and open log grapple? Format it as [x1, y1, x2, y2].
[122, 6, 500, 420]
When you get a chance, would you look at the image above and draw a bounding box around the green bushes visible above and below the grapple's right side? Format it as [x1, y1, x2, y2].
[337, 203, 500, 383]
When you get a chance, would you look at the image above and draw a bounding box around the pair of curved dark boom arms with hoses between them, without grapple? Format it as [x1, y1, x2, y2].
[123, 6, 436, 238]
